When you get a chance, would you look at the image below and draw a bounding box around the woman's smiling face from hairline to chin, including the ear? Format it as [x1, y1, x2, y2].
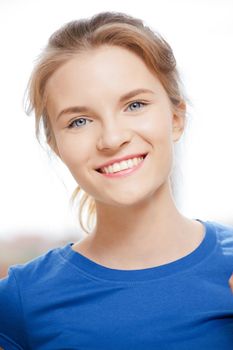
[47, 45, 184, 206]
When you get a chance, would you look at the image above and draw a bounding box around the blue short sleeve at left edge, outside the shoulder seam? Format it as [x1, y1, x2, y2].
[0, 266, 27, 350]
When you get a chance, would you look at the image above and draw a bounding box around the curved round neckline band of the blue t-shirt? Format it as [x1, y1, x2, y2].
[60, 219, 217, 283]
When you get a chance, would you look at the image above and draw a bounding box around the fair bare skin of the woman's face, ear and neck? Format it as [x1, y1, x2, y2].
[47, 46, 204, 269]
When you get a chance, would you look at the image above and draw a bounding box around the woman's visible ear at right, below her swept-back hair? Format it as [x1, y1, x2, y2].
[172, 101, 186, 142]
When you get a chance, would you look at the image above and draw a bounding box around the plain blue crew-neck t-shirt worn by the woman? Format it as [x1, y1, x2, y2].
[0, 220, 233, 350]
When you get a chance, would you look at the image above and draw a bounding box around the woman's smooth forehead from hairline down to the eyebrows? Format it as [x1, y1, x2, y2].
[47, 45, 164, 115]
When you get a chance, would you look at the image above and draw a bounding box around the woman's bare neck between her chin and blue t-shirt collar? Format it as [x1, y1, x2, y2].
[74, 183, 203, 269]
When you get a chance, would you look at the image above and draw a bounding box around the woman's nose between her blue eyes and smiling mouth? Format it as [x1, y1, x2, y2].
[96, 121, 132, 151]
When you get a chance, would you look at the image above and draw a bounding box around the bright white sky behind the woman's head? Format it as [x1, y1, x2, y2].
[0, 0, 233, 238]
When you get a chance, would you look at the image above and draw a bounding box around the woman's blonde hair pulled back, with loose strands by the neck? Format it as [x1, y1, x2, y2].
[26, 12, 184, 233]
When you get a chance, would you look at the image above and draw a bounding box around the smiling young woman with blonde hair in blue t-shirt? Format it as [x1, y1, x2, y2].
[0, 12, 233, 350]
